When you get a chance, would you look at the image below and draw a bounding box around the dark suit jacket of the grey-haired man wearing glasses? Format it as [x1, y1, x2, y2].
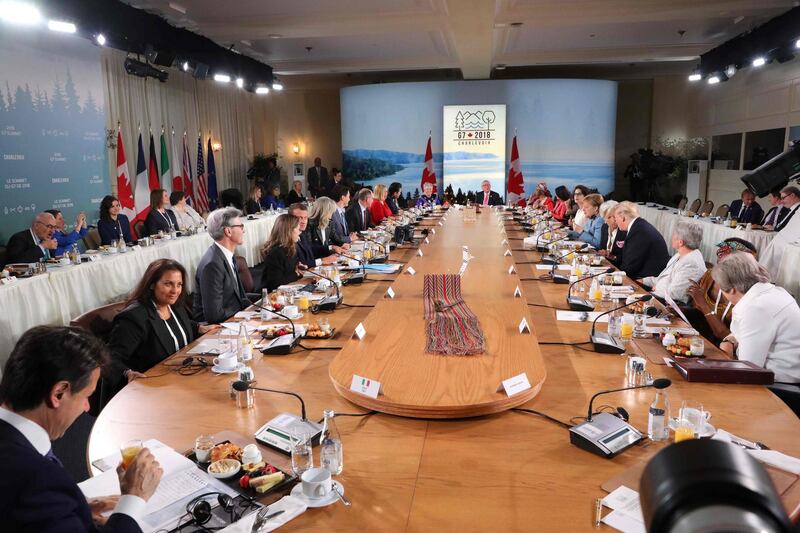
[192, 244, 251, 324]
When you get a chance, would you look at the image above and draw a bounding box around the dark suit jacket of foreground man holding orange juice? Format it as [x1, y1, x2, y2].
[0, 420, 142, 533]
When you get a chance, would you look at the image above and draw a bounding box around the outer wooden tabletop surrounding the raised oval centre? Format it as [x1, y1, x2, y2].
[88, 208, 800, 532]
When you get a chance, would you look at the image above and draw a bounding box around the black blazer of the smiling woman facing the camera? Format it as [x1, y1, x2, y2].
[109, 302, 197, 374]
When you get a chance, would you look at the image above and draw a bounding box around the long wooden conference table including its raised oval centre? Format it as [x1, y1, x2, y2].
[88, 211, 800, 532]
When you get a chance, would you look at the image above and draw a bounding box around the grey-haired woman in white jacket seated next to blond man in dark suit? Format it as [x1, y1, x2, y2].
[638, 220, 706, 303]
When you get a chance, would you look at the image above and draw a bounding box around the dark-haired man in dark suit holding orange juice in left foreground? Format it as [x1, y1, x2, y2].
[0, 326, 162, 533]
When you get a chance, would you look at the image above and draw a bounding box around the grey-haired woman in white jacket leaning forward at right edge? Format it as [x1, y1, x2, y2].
[711, 254, 800, 383]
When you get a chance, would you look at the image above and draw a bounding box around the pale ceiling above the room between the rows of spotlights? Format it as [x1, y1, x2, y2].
[129, 0, 795, 79]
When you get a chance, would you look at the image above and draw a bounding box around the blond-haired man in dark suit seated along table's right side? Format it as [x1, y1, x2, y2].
[614, 202, 669, 279]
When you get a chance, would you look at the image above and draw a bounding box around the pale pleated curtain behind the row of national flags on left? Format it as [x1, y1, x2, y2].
[102, 49, 270, 194]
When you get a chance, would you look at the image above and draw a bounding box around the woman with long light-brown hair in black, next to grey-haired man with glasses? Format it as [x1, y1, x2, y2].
[261, 213, 302, 291]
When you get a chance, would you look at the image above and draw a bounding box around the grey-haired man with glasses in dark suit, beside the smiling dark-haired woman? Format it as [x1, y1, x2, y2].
[193, 207, 251, 324]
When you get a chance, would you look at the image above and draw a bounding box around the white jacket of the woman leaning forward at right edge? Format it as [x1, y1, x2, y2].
[731, 283, 800, 383]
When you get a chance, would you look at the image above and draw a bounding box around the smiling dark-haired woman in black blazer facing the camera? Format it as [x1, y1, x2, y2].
[109, 259, 219, 389]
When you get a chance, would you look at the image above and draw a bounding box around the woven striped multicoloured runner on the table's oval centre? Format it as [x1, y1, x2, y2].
[422, 274, 486, 355]
